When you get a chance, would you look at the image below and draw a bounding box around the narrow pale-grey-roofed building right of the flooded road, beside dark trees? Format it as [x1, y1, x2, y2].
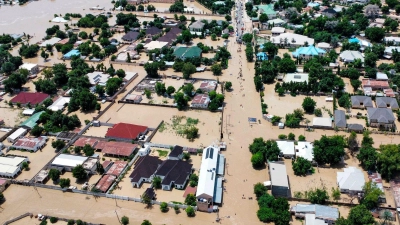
[268, 162, 290, 197]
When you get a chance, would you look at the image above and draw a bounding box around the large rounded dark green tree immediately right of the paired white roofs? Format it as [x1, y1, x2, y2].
[314, 135, 345, 165]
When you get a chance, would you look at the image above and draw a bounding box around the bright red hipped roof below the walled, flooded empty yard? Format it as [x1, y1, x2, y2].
[106, 123, 148, 140]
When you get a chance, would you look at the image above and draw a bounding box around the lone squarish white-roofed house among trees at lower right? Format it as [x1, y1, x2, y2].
[337, 167, 365, 195]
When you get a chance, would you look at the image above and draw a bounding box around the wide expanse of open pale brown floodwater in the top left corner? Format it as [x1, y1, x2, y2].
[0, 0, 112, 42]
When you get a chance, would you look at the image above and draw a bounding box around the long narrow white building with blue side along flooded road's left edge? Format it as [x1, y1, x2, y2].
[196, 146, 225, 212]
